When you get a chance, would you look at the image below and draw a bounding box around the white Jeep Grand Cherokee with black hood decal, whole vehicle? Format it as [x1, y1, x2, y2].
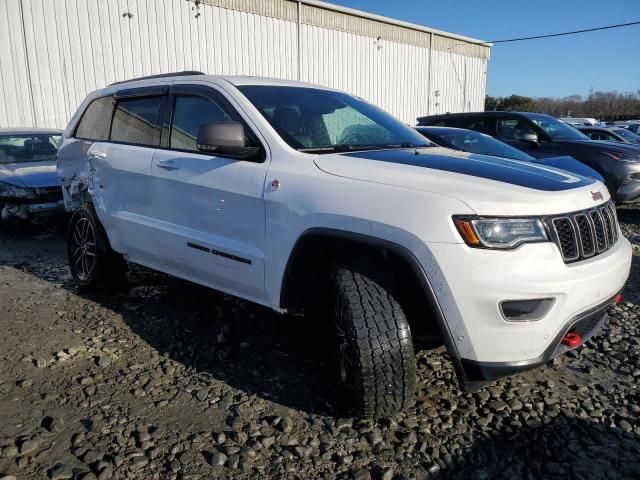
[58, 72, 631, 417]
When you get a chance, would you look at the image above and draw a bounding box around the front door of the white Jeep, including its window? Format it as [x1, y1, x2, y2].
[149, 85, 268, 299]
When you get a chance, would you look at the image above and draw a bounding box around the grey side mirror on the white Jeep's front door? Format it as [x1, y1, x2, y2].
[196, 122, 260, 160]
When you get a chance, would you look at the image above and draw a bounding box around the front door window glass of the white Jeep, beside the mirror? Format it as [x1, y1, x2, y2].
[170, 95, 232, 151]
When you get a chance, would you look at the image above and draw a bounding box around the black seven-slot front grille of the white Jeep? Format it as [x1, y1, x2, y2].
[547, 202, 620, 263]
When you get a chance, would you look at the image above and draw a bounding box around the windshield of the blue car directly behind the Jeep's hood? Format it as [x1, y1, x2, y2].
[429, 130, 534, 162]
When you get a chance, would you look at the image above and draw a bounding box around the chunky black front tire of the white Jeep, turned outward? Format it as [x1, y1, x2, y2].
[330, 257, 416, 418]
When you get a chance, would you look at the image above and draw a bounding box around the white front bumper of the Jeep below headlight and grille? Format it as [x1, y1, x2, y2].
[429, 237, 632, 366]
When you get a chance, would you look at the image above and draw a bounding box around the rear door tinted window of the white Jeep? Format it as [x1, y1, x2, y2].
[111, 97, 164, 146]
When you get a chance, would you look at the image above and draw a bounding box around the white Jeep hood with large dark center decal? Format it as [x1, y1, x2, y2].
[314, 147, 609, 215]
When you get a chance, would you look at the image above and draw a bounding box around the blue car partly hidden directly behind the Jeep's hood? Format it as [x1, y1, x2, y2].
[415, 127, 604, 182]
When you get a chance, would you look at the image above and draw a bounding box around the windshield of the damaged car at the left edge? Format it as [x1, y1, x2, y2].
[0, 134, 60, 164]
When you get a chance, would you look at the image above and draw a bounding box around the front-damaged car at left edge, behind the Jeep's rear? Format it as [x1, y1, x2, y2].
[0, 128, 64, 222]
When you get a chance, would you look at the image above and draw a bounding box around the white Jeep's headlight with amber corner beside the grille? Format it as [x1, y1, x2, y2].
[453, 217, 549, 249]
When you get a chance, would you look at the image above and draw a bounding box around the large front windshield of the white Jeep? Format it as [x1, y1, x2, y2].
[239, 85, 429, 153]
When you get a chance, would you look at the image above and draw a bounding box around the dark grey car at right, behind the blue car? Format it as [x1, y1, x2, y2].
[418, 112, 640, 203]
